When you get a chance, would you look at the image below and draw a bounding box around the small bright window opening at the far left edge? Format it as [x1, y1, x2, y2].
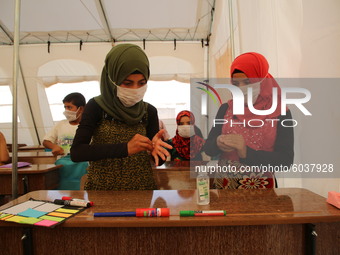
[0, 85, 20, 123]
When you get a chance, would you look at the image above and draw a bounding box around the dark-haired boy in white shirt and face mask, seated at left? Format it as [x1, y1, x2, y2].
[43, 92, 88, 190]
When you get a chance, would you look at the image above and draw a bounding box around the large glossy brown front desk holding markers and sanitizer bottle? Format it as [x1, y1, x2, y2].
[0, 188, 340, 255]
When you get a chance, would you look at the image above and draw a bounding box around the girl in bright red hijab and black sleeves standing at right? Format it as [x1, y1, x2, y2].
[204, 52, 294, 189]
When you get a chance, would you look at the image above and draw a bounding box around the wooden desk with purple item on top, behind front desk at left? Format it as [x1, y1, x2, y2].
[0, 164, 62, 195]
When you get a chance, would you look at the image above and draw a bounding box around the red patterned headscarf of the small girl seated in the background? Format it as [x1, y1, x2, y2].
[172, 111, 205, 160]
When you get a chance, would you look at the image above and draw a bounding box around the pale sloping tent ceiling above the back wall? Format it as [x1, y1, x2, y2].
[0, 0, 215, 45]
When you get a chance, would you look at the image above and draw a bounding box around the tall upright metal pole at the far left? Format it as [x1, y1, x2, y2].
[12, 0, 21, 199]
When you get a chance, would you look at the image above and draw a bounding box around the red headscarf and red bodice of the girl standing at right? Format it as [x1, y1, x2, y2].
[222, 52, 281, 160]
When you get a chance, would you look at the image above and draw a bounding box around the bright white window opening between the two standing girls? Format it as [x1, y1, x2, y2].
[144, 80, 190, 120]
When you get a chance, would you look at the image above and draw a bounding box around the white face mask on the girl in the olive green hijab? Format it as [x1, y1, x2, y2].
[116, 84, 148, 107]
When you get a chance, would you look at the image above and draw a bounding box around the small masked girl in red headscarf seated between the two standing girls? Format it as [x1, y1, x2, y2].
[168, 111, 205, 161]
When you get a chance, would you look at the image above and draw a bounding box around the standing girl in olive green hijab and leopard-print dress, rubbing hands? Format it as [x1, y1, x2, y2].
[71, 44, 171, 190]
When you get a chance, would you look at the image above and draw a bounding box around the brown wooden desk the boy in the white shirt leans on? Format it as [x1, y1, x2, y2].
[9, 151, 57, 164]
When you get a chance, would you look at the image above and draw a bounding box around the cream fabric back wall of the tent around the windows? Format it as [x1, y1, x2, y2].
[0, 42, 205, 144]
